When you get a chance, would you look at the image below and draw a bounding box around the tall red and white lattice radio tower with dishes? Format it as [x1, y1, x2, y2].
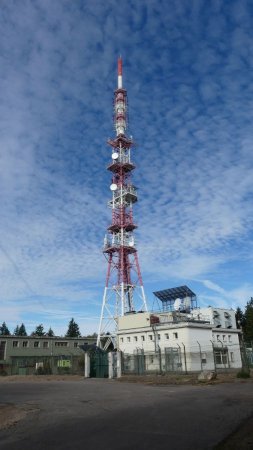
[97, 57, 147, 347]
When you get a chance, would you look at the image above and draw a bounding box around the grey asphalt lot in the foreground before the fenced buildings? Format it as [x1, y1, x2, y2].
[0, 379, 253, 450]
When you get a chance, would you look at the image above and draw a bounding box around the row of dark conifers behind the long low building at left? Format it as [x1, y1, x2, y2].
[0, 318, 96, 337]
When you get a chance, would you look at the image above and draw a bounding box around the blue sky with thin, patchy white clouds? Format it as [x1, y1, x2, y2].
[0, 0, 253, 334]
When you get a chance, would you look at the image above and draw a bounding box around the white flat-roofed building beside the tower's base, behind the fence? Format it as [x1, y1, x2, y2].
[117, 306, 241, 372]
